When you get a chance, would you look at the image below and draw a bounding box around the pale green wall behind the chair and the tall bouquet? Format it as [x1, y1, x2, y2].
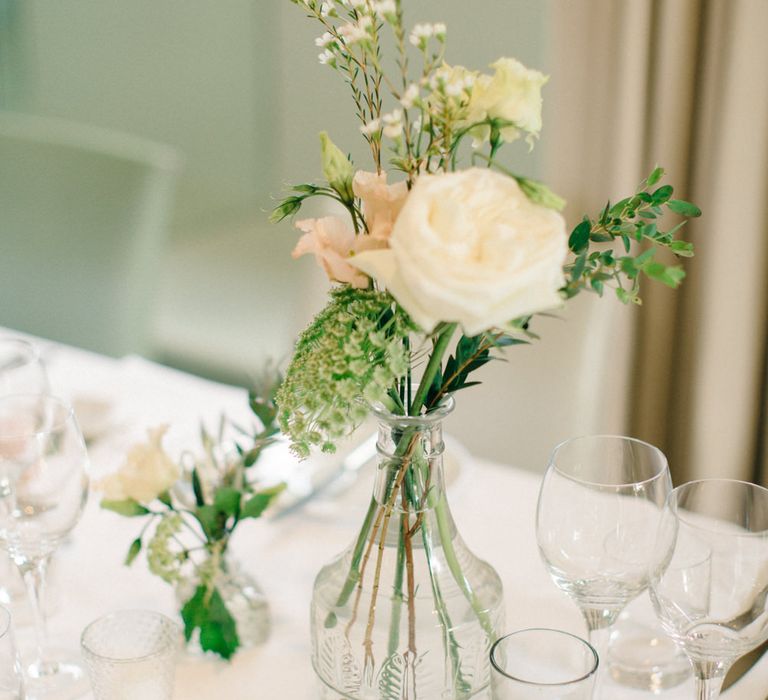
[0, 0, 546, 235]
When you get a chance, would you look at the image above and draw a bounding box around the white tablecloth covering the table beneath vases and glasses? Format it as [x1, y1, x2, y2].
[4, 336, 768, 700]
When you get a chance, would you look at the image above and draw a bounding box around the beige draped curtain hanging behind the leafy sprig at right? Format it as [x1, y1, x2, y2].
[545, 0, 768, 483]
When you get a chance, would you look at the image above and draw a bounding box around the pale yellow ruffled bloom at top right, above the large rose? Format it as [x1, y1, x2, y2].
[467, 58, 549, 141]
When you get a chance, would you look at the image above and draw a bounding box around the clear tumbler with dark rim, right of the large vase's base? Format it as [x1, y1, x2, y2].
[491, 629, 599, 700]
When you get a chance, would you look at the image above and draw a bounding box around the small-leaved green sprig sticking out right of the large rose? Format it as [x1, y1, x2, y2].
[562, 167, 701, 304]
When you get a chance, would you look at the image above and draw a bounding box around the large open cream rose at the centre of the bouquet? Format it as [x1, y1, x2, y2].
[352, 168, 568, 335]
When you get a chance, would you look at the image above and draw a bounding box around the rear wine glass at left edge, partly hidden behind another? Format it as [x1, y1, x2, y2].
[0, 337, 49, 604]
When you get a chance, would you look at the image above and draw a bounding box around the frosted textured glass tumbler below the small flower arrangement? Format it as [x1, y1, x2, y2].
[80, 610, 181, 700]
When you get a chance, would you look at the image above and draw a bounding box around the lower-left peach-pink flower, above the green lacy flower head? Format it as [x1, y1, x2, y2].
[291, 216, 383, 289]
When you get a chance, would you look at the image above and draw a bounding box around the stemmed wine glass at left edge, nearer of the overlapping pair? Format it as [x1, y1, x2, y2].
[0, 394, 88, 698]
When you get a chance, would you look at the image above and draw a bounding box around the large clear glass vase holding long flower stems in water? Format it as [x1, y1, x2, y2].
[311, 398, 504, 700]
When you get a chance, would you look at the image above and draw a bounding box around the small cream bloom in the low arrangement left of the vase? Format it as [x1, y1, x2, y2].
[96, 425, 181, 503]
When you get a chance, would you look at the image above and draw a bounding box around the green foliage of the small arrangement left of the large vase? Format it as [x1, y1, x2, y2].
[101, 369, 285, 659]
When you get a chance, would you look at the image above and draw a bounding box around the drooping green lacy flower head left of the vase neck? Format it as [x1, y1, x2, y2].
[276, 287, 417, 457]
